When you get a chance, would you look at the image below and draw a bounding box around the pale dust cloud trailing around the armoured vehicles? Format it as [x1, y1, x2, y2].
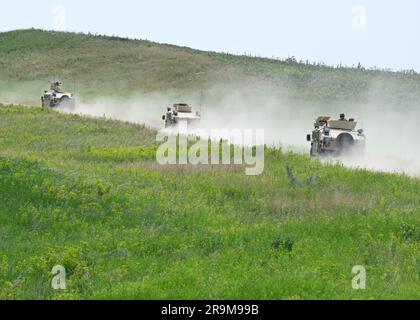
[55, 84, 420, 176]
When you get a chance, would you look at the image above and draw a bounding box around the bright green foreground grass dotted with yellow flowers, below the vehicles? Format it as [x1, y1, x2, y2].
[0, 106, 420, 299]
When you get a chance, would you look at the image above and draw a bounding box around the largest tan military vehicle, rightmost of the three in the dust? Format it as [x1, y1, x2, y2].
[306, 114, 366, 157]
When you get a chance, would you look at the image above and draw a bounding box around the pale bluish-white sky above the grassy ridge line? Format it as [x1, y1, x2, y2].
[0, 0, 420, 71]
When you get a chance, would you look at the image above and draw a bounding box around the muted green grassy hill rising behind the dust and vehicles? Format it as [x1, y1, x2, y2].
[0, 29, 420, 106]
